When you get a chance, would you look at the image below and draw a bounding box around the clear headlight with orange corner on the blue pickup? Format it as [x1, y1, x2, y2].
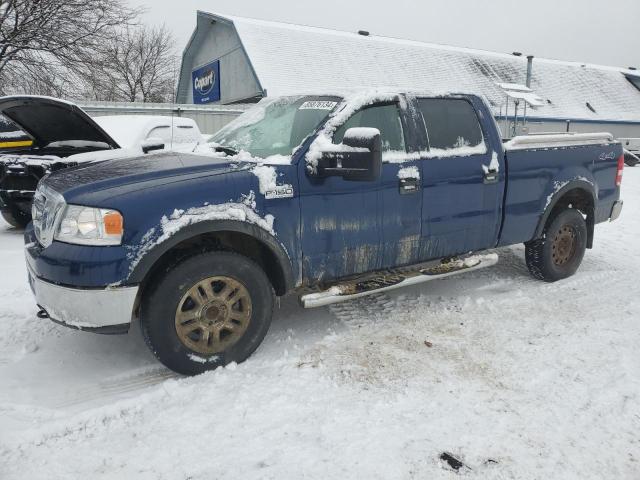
[54, 205, 124, 245]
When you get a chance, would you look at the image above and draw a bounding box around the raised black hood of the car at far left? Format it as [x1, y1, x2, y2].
[0, 96, 120, 150]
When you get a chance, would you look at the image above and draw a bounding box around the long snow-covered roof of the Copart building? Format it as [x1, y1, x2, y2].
[199, 12, 640, 122]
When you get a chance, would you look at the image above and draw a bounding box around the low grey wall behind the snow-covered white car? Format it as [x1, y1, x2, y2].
[74, 101, 246, 134]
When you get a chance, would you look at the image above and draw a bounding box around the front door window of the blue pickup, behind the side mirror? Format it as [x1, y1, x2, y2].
[333, 104, 407, 152]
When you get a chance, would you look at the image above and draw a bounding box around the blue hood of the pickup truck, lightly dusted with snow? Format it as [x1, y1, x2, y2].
[45, 152, 251, 204]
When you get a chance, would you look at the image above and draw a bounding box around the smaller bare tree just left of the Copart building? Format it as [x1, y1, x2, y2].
[102, 25, 176, 102]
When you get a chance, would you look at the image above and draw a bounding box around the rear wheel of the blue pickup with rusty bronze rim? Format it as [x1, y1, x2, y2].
[525, 208, 587, 282]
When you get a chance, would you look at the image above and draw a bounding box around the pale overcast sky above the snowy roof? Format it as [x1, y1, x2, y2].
[125, 0, 640, 69]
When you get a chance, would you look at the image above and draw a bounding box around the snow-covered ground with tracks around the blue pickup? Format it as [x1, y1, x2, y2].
[0, 168, 640, 480]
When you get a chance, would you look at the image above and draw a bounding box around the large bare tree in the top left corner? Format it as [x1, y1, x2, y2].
[0, 0, 139, 93]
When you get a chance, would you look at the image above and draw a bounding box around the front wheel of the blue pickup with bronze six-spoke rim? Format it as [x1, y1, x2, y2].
[140, 252, 275, 375]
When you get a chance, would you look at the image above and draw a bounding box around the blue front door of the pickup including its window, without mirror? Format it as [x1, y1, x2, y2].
[299, 102, 422, 281]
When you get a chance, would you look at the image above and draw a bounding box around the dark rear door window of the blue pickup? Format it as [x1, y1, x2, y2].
[418, 98, 484, 153]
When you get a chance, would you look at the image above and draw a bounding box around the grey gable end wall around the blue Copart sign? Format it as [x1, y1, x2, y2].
[178, 15, 262, 104]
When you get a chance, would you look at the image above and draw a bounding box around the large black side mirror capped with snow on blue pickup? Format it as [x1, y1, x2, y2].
[317, 128, 382, 181]
